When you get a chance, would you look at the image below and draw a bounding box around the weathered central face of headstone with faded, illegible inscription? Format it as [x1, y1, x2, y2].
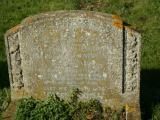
[20, 18, 123, 99]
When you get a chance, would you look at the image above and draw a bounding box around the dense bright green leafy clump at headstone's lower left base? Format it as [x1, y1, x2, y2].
[16, 95, 70, 120]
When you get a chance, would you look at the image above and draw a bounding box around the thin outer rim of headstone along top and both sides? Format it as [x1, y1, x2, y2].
[5, 10, 141, 119]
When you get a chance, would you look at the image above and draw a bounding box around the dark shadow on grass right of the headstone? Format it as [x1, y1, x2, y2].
[140, 69, 160, 120]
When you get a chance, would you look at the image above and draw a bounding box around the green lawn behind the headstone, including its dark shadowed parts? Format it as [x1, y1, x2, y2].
[0, 0, 160, 120]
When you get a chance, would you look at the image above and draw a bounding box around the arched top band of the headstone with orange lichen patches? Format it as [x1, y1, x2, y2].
[5, 10, 140, 36]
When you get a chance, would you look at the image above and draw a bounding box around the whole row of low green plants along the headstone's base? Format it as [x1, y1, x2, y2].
[15, 89, 125, 120]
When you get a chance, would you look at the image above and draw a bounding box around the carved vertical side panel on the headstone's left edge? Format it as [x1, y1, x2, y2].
[6, 33, 24, 89]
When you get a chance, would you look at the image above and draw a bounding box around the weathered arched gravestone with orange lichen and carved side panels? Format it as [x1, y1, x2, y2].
[5, 11, 140, 120]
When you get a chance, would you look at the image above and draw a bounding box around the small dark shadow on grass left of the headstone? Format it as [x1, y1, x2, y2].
[0, 61, 10, 89]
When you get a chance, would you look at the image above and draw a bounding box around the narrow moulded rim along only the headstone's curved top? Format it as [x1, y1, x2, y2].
[5, 10, 139, 36]
